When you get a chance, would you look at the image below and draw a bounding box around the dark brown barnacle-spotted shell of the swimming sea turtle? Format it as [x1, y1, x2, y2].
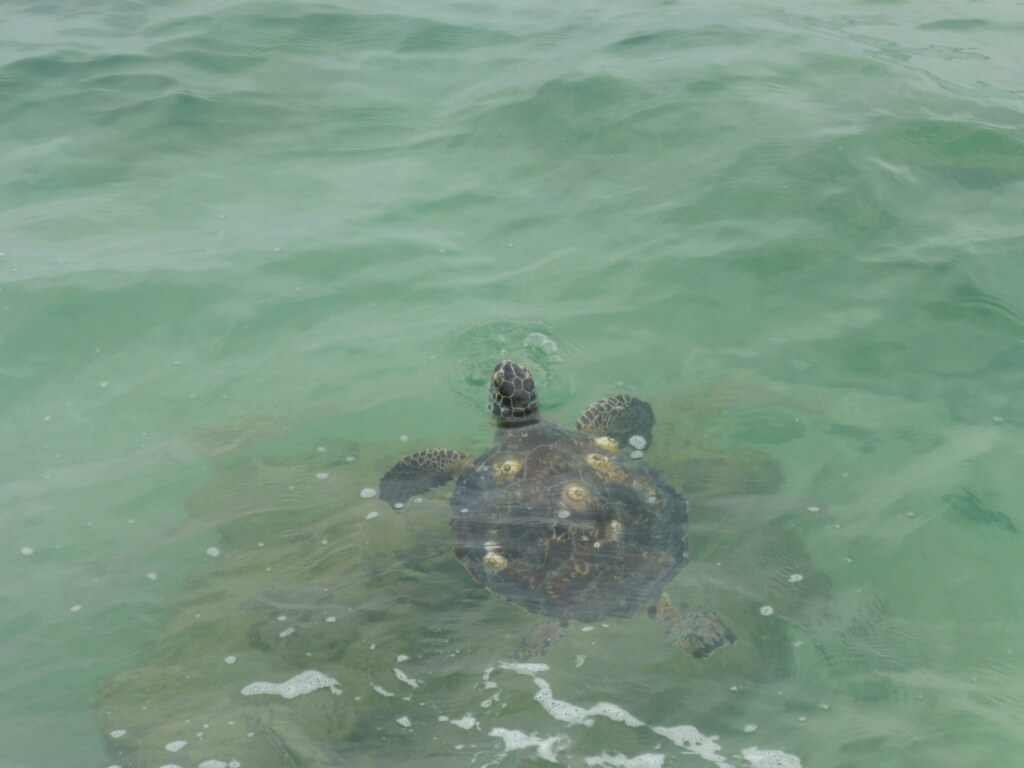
[452, 422, 687, 622]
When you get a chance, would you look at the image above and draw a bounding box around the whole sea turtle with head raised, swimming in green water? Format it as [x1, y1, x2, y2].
[380, 360, 735, 659]
